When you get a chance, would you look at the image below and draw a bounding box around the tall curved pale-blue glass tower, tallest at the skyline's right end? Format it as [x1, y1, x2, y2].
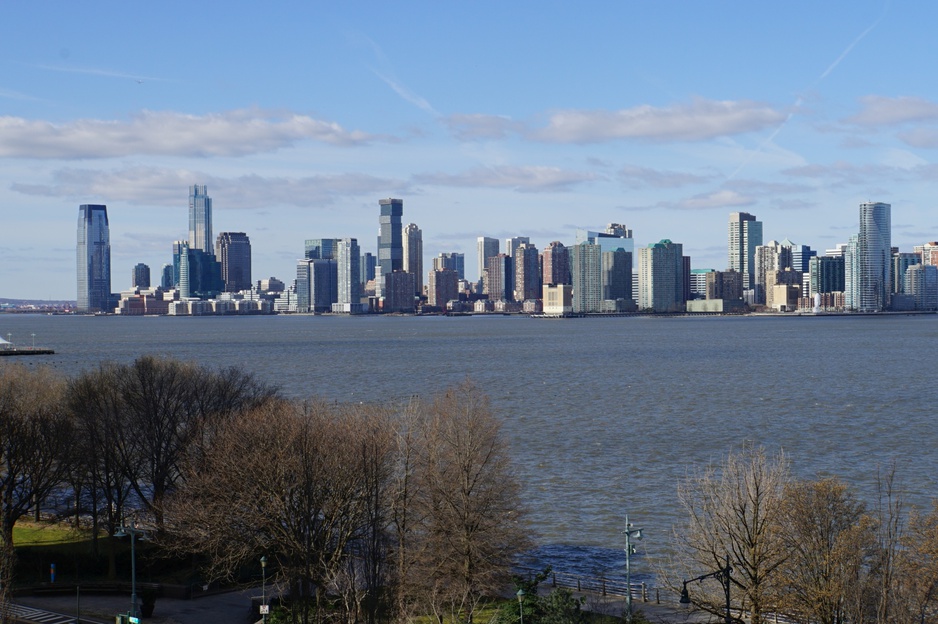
[854, 202, 892, 312]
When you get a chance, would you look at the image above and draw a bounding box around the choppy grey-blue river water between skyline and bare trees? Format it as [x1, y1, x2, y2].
[0, 315, 938, 584]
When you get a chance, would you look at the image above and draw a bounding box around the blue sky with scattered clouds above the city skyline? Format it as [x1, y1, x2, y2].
[0, 0, 938, 299]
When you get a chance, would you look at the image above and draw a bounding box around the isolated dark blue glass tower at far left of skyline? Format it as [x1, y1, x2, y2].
[76, 204, 111, 312]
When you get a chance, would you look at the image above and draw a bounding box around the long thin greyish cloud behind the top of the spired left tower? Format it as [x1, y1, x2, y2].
[11, 167, 408, 209]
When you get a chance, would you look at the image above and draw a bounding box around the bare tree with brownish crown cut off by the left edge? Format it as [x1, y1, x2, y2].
[0, 365, 72, 605]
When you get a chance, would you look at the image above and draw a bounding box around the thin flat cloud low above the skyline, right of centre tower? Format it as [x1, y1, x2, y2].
[413, 166, 601, 193]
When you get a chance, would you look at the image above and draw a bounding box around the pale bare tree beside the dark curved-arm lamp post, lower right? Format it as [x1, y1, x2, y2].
[675, 447, 790, 624]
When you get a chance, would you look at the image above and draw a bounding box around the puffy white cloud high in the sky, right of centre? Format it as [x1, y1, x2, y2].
[530, 98, 786, 143]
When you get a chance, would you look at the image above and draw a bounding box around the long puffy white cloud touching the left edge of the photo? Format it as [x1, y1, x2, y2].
[0, 109, 374, 159]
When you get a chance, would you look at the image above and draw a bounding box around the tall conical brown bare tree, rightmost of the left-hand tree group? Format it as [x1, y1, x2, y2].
[411, 382, 529, 622]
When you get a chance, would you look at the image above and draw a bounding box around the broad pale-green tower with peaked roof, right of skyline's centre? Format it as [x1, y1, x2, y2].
[638, 239, 684, 312]
